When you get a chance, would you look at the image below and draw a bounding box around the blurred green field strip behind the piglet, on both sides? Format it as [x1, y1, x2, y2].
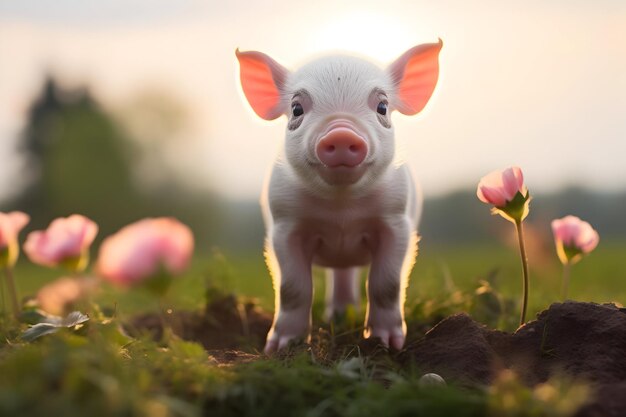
[7, 242, 626, 319]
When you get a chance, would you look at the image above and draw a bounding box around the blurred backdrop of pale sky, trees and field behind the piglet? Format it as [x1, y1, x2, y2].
[0, 0, 626, 322]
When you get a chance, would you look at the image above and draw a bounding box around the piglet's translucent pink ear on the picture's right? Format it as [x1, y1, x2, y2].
[387, 39, 443, 115]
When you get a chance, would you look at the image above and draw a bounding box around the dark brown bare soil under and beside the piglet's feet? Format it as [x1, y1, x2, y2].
[128, 296, 626, 417]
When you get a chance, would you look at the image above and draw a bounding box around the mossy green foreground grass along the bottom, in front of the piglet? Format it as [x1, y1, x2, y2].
[0, 320, 586, 417]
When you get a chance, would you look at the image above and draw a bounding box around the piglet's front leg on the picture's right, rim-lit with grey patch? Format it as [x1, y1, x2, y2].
[365, 216, 417, 349]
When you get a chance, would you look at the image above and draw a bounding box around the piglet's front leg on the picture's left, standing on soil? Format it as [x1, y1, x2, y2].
[264, 224, 313, 354]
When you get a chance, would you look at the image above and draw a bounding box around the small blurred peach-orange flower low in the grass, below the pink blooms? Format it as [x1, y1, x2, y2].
[37, 278, 95, 316]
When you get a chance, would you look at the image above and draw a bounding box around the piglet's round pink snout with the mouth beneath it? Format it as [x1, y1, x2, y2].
[315, 119, 369, 185]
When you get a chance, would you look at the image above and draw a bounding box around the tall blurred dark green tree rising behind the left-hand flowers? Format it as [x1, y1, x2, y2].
[12, 78, 143, 230]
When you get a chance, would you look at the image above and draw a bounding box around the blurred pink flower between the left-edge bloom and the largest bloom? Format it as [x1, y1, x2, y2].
[24, 214, 98, 271]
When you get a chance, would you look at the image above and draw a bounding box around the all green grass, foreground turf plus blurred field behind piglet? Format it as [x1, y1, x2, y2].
[0, 242, 626, 417]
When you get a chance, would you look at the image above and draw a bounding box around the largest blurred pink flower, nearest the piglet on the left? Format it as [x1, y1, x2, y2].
[98, 217, 194, 286]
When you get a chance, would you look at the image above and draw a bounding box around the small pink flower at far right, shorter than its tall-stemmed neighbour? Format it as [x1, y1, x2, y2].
[552, 216, 600, 264]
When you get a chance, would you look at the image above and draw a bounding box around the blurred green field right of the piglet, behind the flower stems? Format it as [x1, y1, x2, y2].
[407, 242, 626, 330]
